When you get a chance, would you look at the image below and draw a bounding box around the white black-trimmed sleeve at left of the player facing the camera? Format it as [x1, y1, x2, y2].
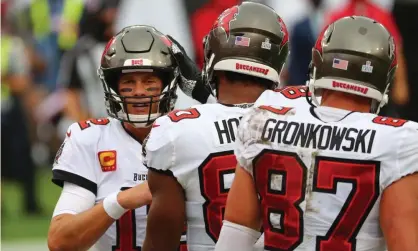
[52, 123, 100, 195]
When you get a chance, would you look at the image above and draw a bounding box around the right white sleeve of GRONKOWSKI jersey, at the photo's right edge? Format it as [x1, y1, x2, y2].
[382, 121, 418, 189]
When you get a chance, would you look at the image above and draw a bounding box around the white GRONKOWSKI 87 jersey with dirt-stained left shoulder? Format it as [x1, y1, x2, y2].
[235, 105, 418, 251]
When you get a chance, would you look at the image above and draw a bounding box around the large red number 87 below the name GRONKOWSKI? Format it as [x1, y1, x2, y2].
[254, 150, 380, 251]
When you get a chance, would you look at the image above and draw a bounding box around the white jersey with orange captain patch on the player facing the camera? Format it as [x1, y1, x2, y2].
[52, 118, 148, 251]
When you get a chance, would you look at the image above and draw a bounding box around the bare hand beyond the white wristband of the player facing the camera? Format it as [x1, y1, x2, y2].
[118, 181, 152, 210]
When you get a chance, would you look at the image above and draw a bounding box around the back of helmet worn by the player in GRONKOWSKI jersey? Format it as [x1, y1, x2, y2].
[308, 16, 397, 113]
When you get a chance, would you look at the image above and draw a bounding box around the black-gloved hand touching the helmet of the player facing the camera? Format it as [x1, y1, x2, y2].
[167, 35, 211, 104]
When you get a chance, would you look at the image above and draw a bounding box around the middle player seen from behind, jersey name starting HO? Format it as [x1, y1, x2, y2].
[142, 2, 289, 251]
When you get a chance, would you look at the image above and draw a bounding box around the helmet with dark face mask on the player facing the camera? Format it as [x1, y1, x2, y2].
[98, 26, 179, 128]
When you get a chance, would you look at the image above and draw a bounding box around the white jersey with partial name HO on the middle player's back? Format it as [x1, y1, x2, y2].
[144, 104, 250, 251]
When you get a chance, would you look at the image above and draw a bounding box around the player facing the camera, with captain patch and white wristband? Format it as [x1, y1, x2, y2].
[48, 26, 186, 251]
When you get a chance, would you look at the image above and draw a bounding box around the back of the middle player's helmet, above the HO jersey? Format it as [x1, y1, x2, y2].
[202, 2, 289, 96]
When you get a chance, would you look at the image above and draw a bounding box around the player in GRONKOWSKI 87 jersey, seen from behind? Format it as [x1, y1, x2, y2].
[215, 16, 418, 251]
